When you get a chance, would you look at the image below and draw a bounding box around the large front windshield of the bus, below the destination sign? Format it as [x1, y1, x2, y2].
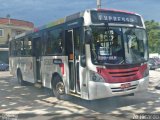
[90, 26, 148, 64]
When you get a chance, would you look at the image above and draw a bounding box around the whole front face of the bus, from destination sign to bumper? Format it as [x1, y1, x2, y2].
[85, 11, 149, 99]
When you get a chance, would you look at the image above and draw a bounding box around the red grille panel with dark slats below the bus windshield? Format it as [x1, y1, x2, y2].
[97, 64, 147, 83]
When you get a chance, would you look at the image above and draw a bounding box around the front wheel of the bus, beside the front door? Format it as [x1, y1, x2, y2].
[52, 75, 65, 100]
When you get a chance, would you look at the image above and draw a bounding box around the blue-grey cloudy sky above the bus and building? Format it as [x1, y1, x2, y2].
[0, 0, 160, 27]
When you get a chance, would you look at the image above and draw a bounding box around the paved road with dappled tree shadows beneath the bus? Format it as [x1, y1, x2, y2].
[0, 70, 160, 120]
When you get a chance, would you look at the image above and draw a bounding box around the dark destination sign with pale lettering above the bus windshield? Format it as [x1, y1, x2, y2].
[91, 11, 142, 26]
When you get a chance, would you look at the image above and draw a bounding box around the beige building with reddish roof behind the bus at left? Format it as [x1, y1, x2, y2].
[0, 17, 34, 63]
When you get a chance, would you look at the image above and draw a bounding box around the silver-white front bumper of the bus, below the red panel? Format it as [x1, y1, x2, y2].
[88, 77, 149, 100]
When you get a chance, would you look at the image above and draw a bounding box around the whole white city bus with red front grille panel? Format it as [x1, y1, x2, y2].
[9, 9, 149, 100]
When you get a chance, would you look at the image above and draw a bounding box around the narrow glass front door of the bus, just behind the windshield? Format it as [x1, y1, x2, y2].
[65, 29, 80, 94]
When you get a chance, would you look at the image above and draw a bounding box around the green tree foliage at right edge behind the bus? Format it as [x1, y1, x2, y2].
[145, 20, 160, 53]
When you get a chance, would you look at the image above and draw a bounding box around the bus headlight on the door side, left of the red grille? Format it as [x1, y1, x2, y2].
[90, 71, 105, 82]
